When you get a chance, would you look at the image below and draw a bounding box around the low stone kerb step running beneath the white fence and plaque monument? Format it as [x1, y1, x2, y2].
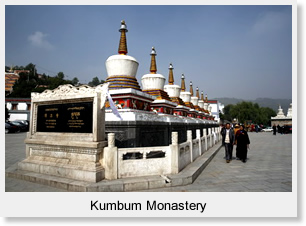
[5, 143, 222, 192]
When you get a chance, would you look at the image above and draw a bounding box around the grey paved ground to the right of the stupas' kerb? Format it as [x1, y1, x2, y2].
[139, 133, 292, 192]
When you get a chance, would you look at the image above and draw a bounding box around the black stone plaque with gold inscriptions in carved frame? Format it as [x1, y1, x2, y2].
[36, 102, 93, 133]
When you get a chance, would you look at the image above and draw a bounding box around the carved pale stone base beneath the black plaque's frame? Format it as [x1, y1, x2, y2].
[18, 139, 106, 182]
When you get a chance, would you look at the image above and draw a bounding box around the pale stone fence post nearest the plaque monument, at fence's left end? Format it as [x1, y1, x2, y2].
[104, 133, 118, 180]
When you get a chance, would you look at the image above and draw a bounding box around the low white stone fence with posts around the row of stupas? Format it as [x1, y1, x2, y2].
[101, 128, 221, 180]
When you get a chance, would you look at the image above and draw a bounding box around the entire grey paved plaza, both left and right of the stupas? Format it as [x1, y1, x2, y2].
[5, 132, 292, 192]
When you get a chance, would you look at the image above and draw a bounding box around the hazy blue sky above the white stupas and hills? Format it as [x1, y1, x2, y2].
[5, 5, 292, 100]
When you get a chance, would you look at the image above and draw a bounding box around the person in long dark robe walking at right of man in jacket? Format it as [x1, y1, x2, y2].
[236, 125, 250, 163]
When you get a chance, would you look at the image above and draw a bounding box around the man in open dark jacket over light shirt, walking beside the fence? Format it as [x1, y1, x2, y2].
[222, 123, 235, 163]
